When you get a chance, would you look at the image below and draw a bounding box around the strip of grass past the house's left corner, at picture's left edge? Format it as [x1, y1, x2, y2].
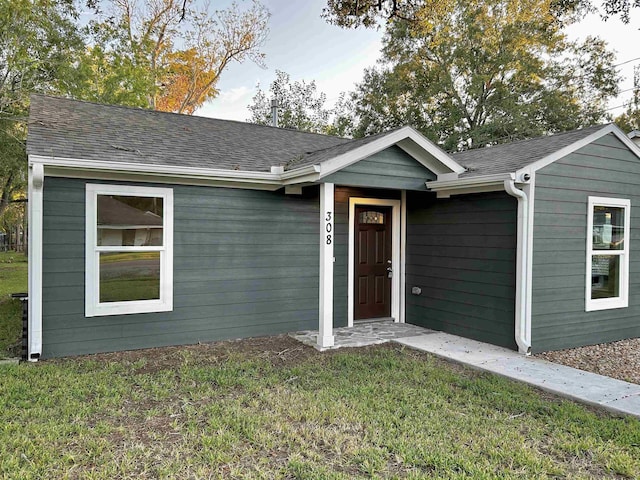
[0, 252, 27, 359]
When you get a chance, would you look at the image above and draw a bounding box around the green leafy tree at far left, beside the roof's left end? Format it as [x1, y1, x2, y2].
[0, 0, 84, 216]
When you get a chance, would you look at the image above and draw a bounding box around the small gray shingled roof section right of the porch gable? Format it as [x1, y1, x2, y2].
[451, 125, 603, 178]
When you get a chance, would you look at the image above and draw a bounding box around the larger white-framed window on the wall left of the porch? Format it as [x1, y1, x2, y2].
[85, 184, 173, 317]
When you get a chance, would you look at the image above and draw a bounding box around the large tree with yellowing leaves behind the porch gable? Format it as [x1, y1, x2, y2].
[342, 0, 618, 150]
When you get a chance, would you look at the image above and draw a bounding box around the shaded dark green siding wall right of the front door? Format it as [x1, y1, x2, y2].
[406, 192, 517, 349]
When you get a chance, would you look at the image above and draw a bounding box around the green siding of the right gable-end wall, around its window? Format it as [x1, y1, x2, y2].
[531, 134, 640, 352]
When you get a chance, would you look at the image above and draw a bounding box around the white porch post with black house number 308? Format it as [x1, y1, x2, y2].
[317, 183, 334, 349]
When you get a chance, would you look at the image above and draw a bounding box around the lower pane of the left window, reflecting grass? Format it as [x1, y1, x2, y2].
[100, 252, 160, 303]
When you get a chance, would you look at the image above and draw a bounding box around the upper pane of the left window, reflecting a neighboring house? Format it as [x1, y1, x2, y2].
[97, 195, 163, 246]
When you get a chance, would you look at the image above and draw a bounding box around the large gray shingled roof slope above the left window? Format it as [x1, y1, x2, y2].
[27, 95, 351, 172]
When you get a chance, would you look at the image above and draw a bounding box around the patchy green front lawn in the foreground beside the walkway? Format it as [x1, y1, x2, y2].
[0, 337, 640, 479]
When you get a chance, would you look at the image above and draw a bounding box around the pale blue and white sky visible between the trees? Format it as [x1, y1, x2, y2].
[196, 0, 640, 121]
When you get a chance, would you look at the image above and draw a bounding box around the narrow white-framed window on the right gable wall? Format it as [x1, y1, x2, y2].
[585, 197, 631, 312]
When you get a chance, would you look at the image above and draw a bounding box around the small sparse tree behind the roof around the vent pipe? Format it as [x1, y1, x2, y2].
[247, 70, 334, 133]
